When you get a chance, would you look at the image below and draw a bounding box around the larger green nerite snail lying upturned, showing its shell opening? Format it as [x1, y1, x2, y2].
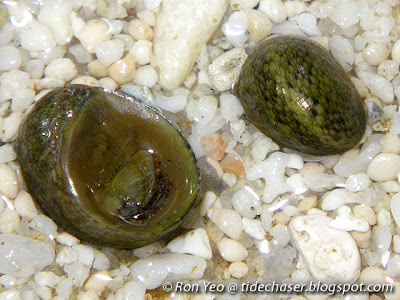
[16, 85, 199, 248]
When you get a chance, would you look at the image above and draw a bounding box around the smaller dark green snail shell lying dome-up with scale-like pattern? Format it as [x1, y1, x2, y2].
[234, 35, 367, 155]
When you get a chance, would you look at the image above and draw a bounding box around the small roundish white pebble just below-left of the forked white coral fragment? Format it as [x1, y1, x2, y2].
[232, 186, 262, 219]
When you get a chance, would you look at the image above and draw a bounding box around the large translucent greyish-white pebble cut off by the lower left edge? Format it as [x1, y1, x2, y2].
[0, 233, 54, 277]
